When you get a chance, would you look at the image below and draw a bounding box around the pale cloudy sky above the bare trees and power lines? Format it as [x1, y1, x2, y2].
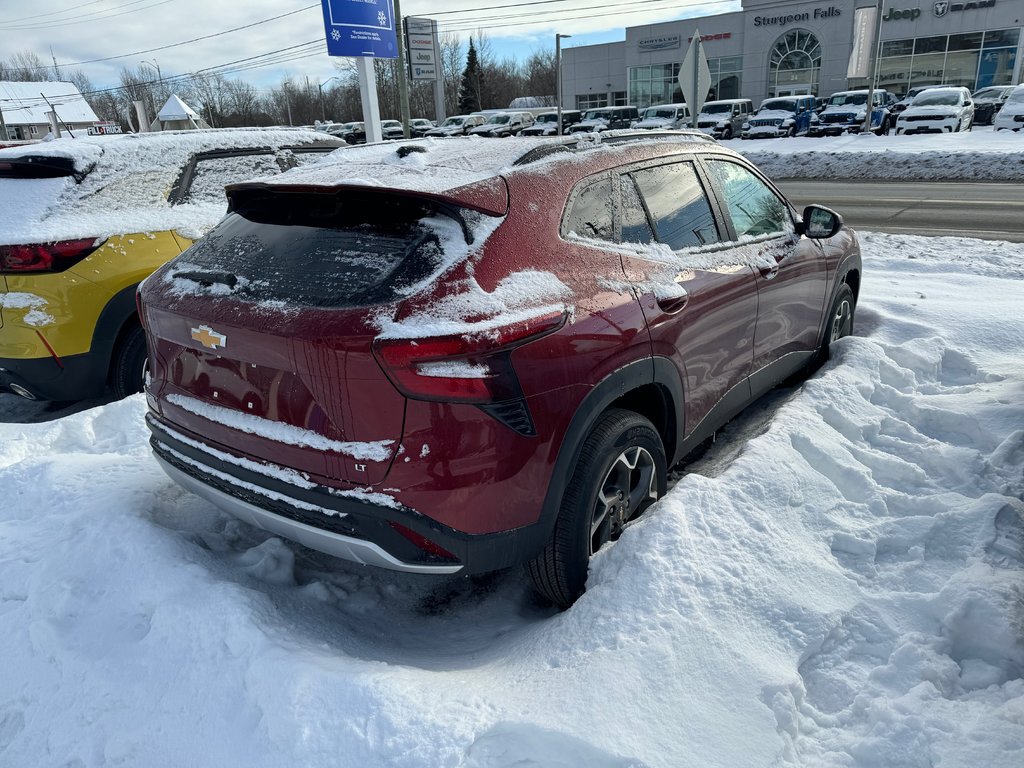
[0, 0, 739, 94]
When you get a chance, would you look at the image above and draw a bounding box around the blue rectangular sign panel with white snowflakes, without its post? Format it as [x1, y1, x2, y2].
[321, 0, 398, 58]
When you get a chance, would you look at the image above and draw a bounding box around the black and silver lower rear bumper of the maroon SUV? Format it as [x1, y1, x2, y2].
[145, 414, 544, 574]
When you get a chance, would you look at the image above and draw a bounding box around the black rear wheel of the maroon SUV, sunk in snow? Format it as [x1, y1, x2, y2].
[526, 409, 668, 608]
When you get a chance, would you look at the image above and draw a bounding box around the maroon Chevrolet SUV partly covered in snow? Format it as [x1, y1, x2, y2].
[140, 131, 861, 606]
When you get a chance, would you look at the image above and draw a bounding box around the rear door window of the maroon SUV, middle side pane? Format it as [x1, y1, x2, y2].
[624, 163, 720, 251]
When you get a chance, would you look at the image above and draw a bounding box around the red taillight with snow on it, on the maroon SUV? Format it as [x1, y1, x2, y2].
[374, 312, 566, 402]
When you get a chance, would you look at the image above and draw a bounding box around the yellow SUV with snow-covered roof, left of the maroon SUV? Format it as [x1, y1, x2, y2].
[0, 129, 344, 400]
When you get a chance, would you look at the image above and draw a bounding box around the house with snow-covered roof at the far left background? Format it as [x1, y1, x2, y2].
[0, 81, 99, 140]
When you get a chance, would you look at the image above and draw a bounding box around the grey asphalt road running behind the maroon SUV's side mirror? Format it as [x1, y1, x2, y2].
[776, 179, 1024, 243]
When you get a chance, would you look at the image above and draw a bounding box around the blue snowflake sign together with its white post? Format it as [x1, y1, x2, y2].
[321, 0, 398, 143]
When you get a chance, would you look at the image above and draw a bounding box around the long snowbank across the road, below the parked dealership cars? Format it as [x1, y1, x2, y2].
[722, 126, 1024, 181]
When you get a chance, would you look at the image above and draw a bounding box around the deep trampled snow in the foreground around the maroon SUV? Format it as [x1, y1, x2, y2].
[0, 234, 1024, 768]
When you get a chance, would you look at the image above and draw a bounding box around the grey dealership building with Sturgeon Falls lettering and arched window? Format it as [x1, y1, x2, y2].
[562, 0, 1024, 110]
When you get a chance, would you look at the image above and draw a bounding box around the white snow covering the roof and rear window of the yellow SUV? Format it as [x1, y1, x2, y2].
[0, 128, 336, 244]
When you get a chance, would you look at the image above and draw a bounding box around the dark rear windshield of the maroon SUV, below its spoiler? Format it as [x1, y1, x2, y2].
[168, 191, 461, 307]
